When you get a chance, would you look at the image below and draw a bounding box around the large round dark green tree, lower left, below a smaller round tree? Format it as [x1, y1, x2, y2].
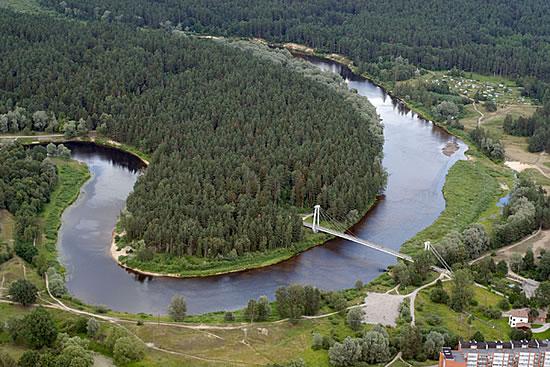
[23, 307, 57, 349]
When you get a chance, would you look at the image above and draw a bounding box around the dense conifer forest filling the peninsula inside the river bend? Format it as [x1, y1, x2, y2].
[0, 12, 385, 258]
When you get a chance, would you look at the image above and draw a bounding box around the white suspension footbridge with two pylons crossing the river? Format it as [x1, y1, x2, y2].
[303, 205, 452, 274]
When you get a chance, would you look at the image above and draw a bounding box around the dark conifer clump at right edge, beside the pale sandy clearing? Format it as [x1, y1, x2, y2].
[503, 100, 550, 152]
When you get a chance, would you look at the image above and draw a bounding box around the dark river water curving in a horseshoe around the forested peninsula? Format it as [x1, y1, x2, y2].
[58, 59, 467, 314]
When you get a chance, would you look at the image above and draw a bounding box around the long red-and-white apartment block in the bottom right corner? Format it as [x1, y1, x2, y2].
[439, 340, 550, 367]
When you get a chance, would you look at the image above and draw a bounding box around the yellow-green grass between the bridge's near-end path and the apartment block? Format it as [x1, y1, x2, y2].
[416, 283, 510, 340]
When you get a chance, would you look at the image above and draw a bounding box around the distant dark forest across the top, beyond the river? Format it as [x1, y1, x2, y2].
[41, 0, 550, 80]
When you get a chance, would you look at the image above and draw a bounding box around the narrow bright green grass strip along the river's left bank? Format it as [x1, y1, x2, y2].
[40, 158, 90, 268]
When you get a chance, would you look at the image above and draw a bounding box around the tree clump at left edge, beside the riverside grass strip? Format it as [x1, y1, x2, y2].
[0, 143, 57, 244]
